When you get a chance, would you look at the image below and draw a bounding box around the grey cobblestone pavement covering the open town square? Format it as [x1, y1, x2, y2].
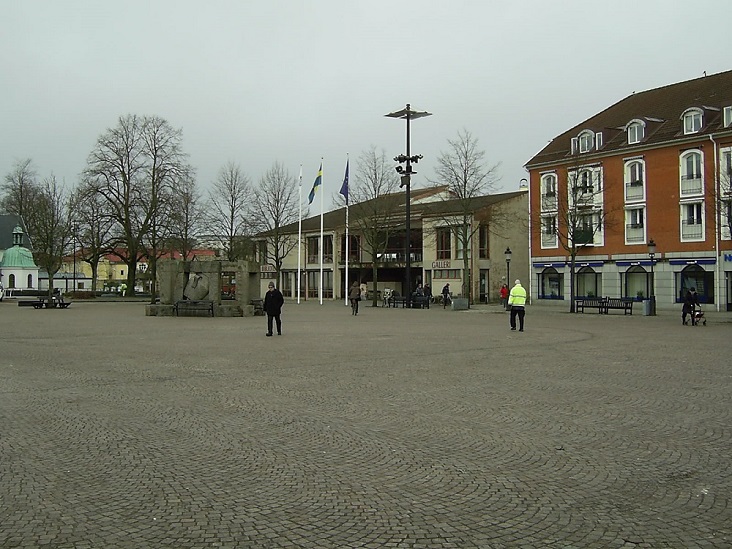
[0, 301, 732, 549]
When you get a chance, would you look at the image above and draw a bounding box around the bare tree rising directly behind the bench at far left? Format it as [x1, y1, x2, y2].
[33, 175, 72, 296]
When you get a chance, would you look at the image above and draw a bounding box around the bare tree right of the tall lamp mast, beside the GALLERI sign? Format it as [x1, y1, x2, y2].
[430, 130, 500, 303]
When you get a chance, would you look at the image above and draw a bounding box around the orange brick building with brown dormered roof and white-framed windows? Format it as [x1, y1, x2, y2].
[526, 71, 732, 310]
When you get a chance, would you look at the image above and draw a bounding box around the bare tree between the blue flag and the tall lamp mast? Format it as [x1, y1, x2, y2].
[346, 146, 404, 306]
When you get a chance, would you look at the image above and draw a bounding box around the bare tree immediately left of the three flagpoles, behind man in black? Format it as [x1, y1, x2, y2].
[249, 162, 300, 280]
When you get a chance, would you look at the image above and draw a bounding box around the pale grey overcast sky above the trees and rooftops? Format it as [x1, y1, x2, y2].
[0, 0, 732, 206]
